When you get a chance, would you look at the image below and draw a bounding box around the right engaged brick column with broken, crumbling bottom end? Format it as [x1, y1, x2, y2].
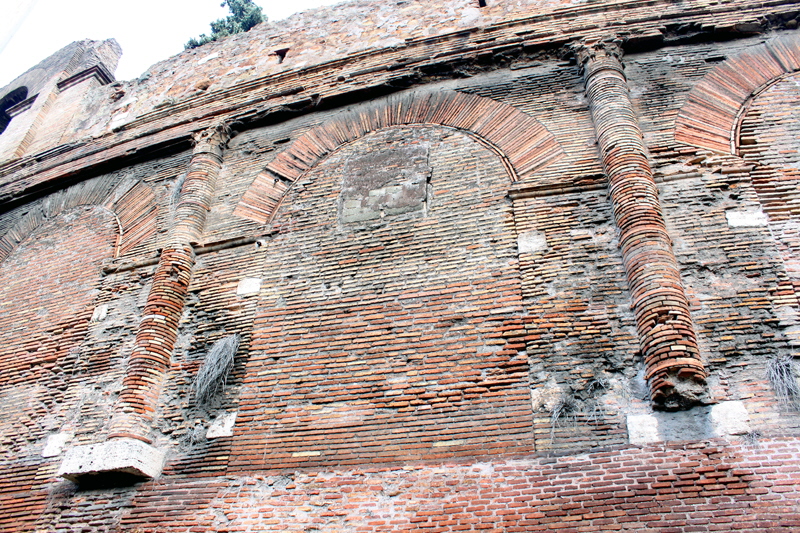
[576, 43, 706, 409]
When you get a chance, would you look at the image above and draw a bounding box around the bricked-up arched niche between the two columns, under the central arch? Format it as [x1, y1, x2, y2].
[230, 124, 533, 471]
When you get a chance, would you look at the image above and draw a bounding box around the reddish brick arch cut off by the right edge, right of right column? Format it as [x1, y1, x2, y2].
[675, 35, 800, 154]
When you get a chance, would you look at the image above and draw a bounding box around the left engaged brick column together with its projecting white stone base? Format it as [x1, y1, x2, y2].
[59, 124, 230, 482]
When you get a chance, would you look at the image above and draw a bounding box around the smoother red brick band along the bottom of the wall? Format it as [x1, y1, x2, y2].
[6, 439, 800, 533]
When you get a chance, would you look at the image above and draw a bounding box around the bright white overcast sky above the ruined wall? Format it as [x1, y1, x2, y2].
[0, 0, 342, 87]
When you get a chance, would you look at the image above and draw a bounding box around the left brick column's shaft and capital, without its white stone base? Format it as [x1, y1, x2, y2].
[109, 121, 230, 443]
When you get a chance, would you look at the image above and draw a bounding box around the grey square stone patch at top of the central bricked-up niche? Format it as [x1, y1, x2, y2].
[339, 143, 431, 224]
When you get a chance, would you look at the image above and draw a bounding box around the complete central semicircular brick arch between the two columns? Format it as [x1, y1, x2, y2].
[234, 91, 564, 223]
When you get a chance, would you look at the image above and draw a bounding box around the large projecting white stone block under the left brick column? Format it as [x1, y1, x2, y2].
[58, 438, 164, 483]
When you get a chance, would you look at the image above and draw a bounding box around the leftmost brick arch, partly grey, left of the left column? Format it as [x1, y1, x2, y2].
[0, 175, 158, 262]
